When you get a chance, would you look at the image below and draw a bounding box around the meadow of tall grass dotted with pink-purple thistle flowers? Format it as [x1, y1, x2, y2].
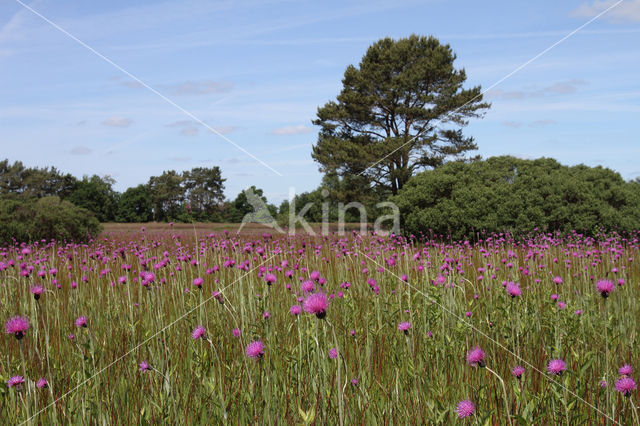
[0, 225, 640, 425]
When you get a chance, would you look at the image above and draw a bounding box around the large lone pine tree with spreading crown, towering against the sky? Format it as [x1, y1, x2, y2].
[312, 35, 489, 195]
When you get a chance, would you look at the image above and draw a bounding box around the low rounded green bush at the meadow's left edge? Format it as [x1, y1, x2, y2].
[0, 197, 101, 243]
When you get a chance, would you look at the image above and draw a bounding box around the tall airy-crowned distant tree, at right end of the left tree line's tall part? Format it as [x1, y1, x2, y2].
[182, 166, 226, 220]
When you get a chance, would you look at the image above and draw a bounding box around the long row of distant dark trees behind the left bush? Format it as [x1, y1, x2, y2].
[0, 159, 278, 222]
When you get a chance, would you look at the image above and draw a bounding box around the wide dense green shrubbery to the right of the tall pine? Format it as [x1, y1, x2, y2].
[393, 156, 640, 238]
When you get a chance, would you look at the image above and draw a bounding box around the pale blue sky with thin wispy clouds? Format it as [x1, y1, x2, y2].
[0, 0, 640, 204]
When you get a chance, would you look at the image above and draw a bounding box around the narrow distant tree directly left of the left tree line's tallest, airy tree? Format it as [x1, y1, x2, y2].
[149, 170, 185, 221]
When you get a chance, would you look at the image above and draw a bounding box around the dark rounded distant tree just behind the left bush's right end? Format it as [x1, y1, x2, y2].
[68, 175, 119, 222]
